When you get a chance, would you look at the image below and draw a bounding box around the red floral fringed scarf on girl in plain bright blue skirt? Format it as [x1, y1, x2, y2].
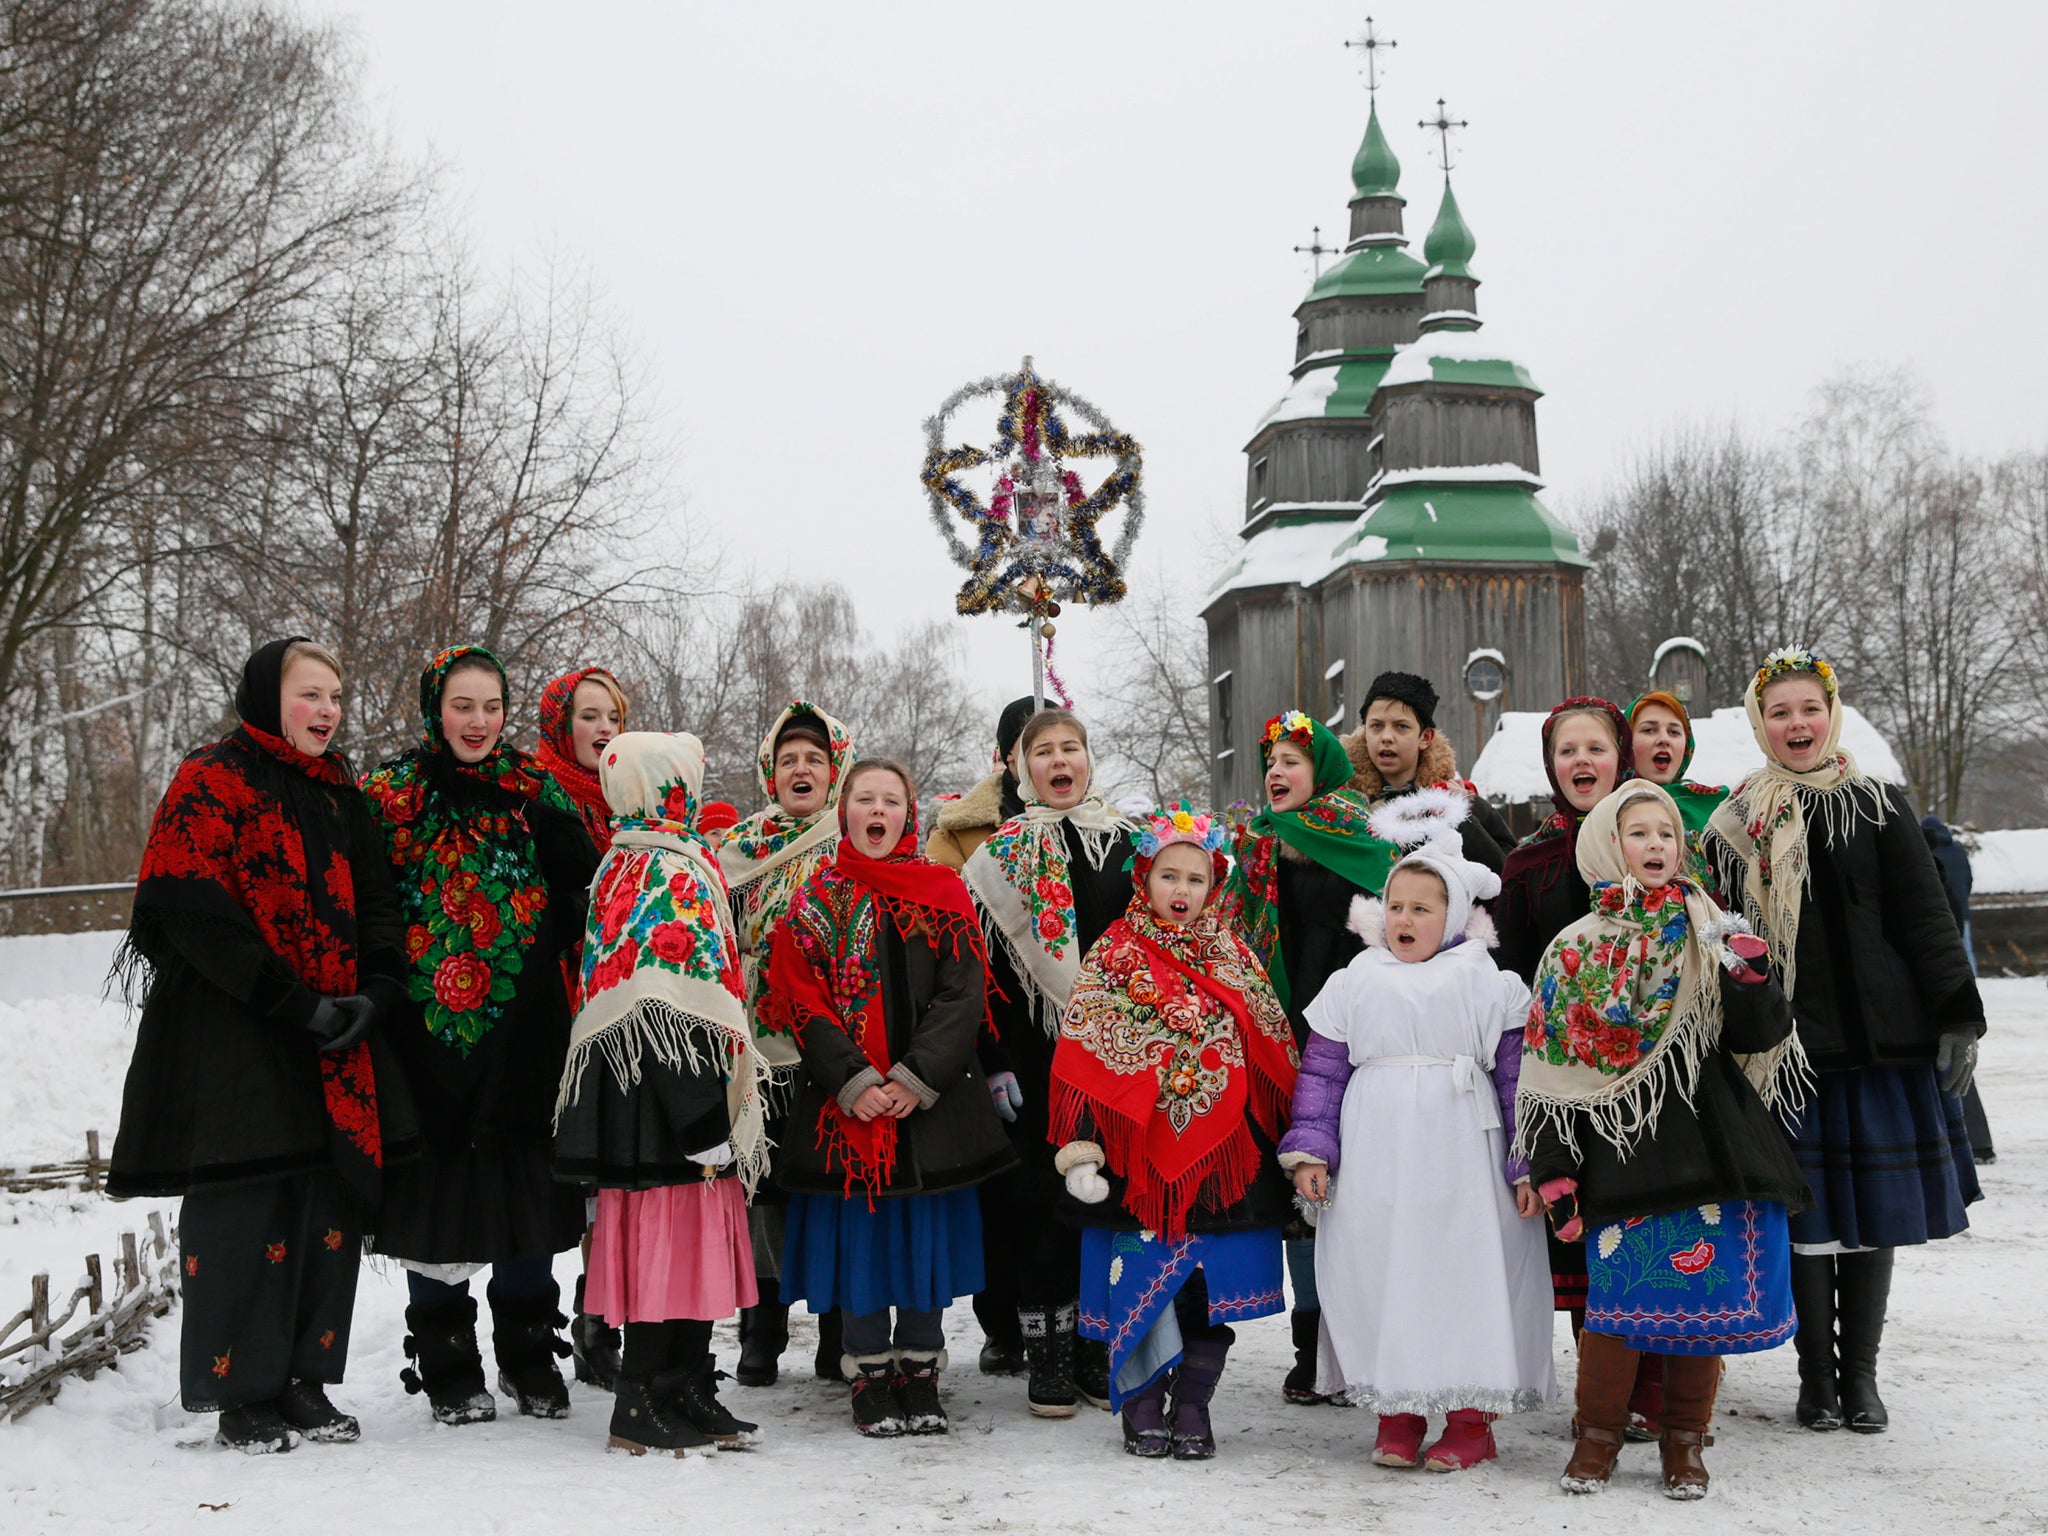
[768, 815, 989, 1204]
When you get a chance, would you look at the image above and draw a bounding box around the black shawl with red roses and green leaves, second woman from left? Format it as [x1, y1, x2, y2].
[362, 645, 575, 1057]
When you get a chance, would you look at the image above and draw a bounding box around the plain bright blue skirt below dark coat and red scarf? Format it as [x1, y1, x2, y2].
[780, 1190, 983, 1317]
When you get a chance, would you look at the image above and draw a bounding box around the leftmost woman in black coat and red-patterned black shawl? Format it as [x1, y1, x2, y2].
[106, 637, 418, 1452]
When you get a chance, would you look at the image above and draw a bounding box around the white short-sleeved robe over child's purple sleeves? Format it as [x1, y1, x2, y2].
[1307, 940, 1556, 1413]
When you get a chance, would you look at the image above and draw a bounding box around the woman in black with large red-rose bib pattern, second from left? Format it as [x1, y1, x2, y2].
[362, 645, 598, 1423]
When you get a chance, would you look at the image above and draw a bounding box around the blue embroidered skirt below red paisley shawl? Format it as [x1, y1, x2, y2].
[1081, 1227, 1286, 1411]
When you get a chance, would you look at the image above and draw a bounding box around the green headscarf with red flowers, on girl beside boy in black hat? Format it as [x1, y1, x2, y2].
[1223, 709, 1401, 1010]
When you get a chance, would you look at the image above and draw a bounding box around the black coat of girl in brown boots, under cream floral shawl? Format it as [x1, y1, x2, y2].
[1530, 971, 1812, 1231]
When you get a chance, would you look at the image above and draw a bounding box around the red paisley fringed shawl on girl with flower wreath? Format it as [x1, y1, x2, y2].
[1051, 893, 1300, 1237]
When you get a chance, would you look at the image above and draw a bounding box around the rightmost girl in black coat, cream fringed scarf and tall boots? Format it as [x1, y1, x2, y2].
[1704, 649, 1985, 1434]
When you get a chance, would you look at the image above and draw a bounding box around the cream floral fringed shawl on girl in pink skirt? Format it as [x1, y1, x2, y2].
[555, 731, 766, 1188]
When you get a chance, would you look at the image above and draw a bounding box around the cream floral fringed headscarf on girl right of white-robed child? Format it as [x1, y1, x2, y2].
[1516, 778, 1804, 1157]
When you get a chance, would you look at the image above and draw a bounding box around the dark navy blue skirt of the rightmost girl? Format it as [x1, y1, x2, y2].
[1792, 1065, 1982, 1247]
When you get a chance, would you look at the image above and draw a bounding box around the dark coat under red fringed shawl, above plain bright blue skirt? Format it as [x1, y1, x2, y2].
[776, 913, 1016, 1198]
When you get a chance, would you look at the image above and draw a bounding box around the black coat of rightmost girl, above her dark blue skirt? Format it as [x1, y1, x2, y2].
[1708, 782, 1985, 1071]
